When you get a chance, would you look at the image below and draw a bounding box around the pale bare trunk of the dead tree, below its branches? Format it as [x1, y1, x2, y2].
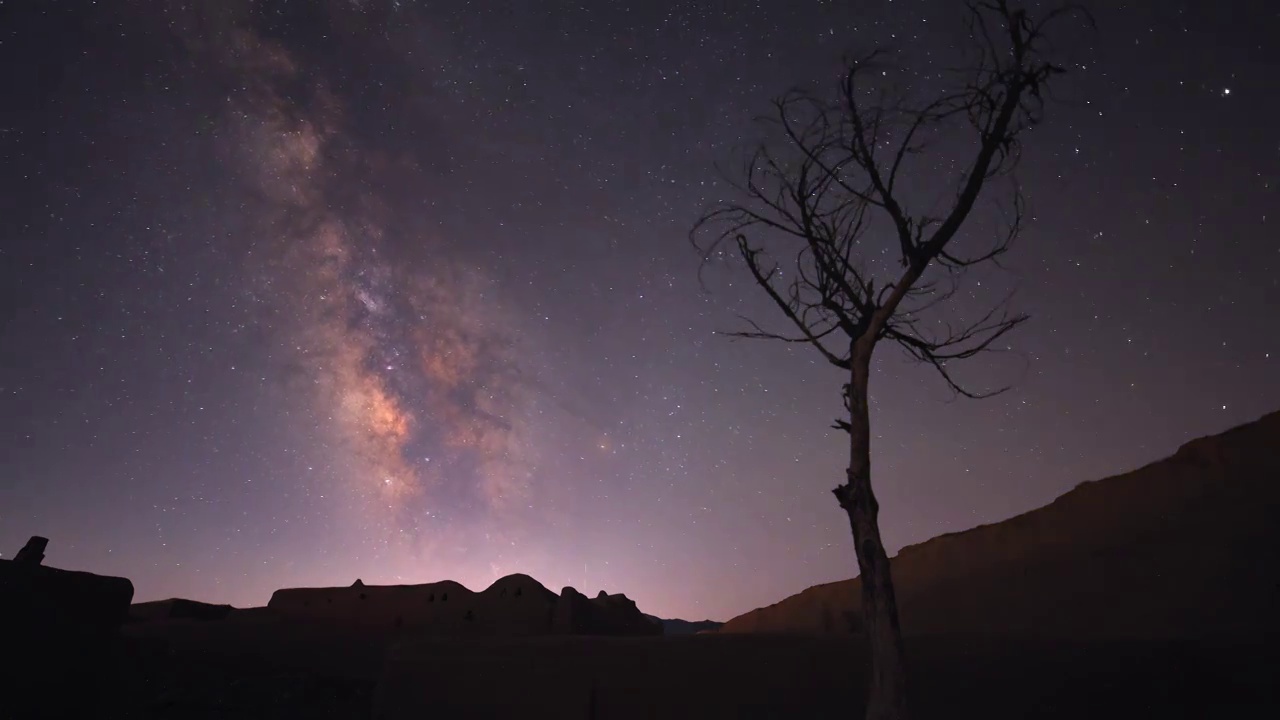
[835, 343, 908, 720]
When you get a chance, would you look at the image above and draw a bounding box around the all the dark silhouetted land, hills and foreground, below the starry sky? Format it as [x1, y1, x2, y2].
[12, 413, 1280, 720]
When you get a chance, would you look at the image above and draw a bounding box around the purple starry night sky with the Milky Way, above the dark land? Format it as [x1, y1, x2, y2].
[0, 0, 1280, 620]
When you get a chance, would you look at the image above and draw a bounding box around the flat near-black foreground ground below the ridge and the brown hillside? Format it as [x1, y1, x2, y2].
[12, 616, 1280, 720]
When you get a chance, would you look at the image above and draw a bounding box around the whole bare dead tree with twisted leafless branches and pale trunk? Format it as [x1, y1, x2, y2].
[690, 0, 1092, 720]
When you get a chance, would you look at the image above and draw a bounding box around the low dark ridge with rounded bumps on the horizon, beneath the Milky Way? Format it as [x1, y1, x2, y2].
[268, 574, 660, 637]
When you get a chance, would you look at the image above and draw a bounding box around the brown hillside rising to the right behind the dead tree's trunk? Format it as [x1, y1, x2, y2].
[721, 413, 1280, 638]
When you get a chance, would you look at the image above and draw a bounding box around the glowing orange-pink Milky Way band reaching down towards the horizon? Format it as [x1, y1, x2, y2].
[190, 11, 555, 562]
